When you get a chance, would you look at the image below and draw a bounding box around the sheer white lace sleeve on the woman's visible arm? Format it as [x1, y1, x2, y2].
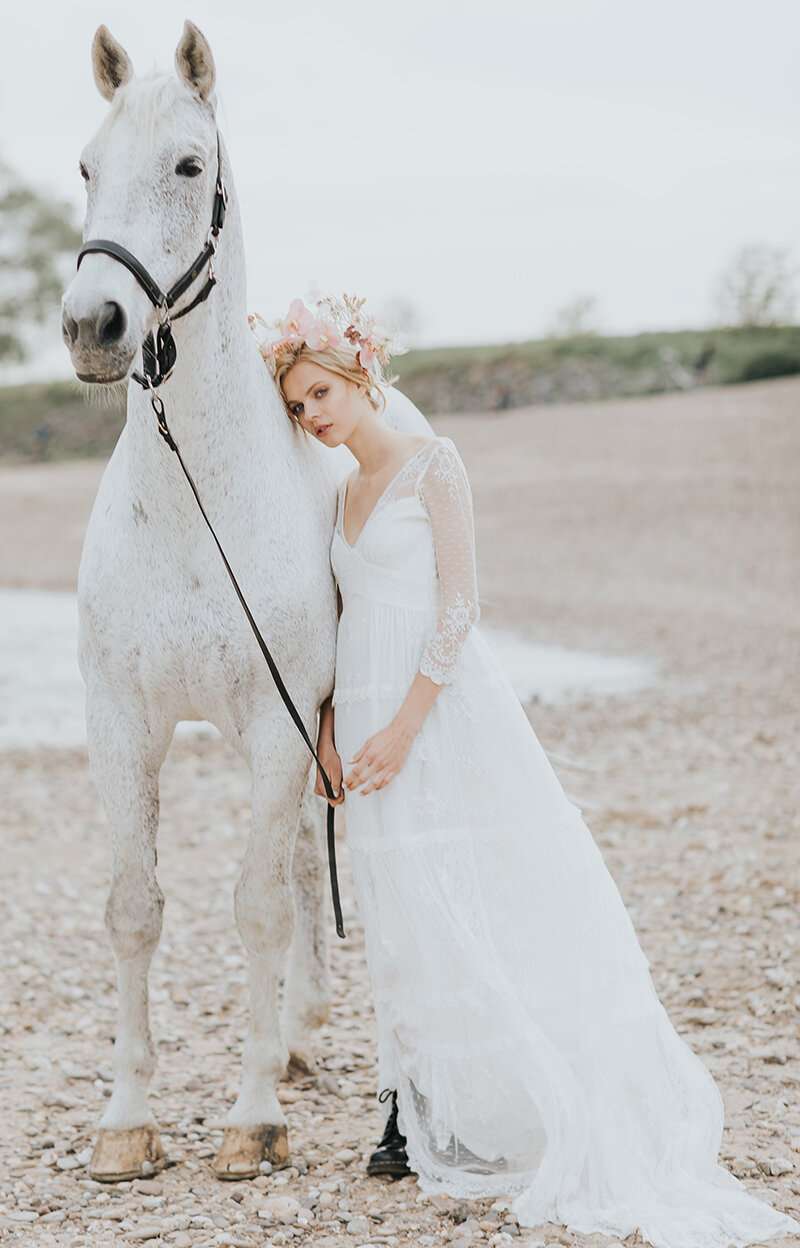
[417, 438, 480, 685]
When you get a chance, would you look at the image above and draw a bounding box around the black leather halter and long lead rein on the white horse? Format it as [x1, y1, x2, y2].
[76, 131, 344, 938]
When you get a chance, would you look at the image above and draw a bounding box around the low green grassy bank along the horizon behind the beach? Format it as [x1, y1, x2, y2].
[0, 326, 800, 461]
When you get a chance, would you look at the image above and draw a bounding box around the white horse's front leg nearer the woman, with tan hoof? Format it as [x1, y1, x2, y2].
[212, 723, 310, 1179]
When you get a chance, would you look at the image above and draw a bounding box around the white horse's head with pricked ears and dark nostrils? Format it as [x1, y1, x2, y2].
[61, 21, 223, 384]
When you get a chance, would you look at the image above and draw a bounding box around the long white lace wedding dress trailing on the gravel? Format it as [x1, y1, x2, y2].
[331, 436, 800, 1248]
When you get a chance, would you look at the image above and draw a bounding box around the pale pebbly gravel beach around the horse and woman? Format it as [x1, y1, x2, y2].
[0, 379, 800, 1248]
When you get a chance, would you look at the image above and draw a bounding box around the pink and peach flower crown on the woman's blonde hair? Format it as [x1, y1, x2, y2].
[247, 295, 408, 382]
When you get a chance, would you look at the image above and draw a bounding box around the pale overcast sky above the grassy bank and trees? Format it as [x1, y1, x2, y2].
[0, 0, 800, 371]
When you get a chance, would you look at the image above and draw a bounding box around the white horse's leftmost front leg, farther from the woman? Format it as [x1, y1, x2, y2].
[86, 683, 175, 1183]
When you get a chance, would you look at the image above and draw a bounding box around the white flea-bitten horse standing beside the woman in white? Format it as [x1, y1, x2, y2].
[62, 21, 432, 1182]
